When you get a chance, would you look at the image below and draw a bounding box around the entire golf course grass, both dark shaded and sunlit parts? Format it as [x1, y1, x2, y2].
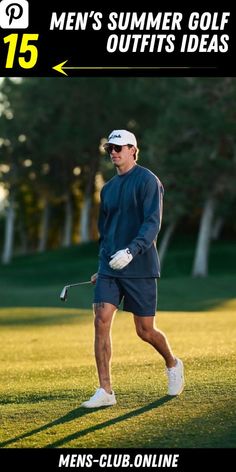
[0, 239, 236, 448]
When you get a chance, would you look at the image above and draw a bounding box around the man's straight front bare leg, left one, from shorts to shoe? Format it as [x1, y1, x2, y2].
[93, 302, 117, 393]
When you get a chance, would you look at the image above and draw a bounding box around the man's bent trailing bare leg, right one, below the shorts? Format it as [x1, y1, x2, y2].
[134, 315, 176, 369]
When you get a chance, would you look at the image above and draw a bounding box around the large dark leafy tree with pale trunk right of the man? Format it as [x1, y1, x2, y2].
[136, 78, 235, 276]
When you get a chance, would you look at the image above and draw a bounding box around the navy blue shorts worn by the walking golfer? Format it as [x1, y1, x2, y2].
[93, 275, 157, 316]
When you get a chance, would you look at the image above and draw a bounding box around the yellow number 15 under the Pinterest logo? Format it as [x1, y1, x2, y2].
[4, 34, 39, 69]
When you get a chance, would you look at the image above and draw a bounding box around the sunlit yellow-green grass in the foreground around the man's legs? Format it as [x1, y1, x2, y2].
[0, 300, 236, 448]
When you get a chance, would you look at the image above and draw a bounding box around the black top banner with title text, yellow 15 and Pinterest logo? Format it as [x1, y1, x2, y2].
[0, 0, 236, 77]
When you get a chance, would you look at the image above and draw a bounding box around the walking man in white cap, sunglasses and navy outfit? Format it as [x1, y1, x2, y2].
[82, 130, 184, 408]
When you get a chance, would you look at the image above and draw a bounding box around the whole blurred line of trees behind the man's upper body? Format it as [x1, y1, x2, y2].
[0, 77, 236, 276]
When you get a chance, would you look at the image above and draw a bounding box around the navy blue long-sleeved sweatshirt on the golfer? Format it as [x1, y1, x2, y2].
[98, 164, 164, 278]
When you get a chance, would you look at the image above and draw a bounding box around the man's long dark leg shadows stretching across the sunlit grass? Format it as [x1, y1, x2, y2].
[0, 395, 175, 448]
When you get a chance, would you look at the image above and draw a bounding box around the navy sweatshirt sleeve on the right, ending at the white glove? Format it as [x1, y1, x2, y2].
[128, 178, 164, 257]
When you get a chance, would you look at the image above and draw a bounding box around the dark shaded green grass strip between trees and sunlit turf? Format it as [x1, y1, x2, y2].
[0, 239, 236, 311]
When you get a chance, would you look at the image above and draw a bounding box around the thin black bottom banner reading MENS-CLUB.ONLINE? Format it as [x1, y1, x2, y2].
[1, 448, 235, 472]
